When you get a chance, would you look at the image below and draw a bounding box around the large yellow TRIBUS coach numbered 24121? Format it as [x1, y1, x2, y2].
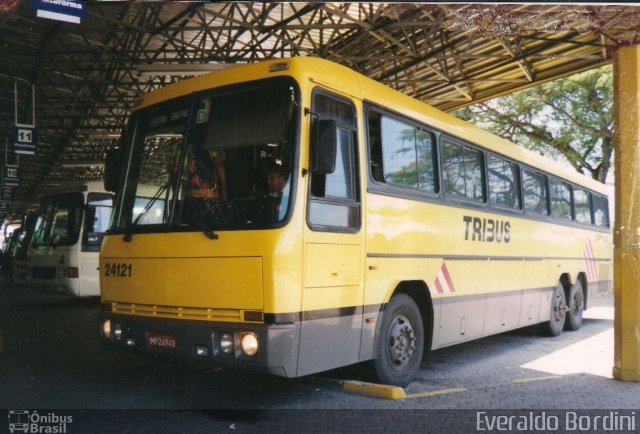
[100, 58, 612, 385]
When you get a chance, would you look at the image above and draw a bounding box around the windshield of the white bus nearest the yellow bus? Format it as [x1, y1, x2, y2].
[33, 193, 84, 247]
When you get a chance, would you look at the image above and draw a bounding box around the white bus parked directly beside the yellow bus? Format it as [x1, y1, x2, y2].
[29, 181, 113, 296]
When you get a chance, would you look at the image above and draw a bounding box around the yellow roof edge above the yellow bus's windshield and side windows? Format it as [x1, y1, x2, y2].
[136, 57, 609, 195]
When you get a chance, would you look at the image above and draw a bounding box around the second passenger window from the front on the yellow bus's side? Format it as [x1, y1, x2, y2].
[442, 140, 484, 202]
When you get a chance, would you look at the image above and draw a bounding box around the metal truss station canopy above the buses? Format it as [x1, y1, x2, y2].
[0, 0, 640, 217]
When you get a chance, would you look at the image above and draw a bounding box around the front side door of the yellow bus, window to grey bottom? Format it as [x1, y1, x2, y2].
[298, 88, 364, 375]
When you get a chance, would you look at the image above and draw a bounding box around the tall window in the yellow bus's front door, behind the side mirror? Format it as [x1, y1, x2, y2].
[307, 91, 360, 232]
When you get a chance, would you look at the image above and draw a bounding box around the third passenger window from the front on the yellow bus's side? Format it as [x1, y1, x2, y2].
[487, 155, 520, 209]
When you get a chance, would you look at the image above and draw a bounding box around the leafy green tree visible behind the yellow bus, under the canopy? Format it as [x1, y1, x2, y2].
[454, 65, 613, 182]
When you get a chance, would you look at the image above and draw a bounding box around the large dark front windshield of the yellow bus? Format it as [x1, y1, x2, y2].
[111, 77, 299, 234]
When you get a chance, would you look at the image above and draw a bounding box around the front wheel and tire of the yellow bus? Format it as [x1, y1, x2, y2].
[374, 294, 424, 387]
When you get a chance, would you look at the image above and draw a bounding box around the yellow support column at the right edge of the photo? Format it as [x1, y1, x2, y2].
[613, 45, 640, 381]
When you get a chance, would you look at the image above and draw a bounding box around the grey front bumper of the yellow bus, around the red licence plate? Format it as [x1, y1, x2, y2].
[100, 312, 299, 377]
